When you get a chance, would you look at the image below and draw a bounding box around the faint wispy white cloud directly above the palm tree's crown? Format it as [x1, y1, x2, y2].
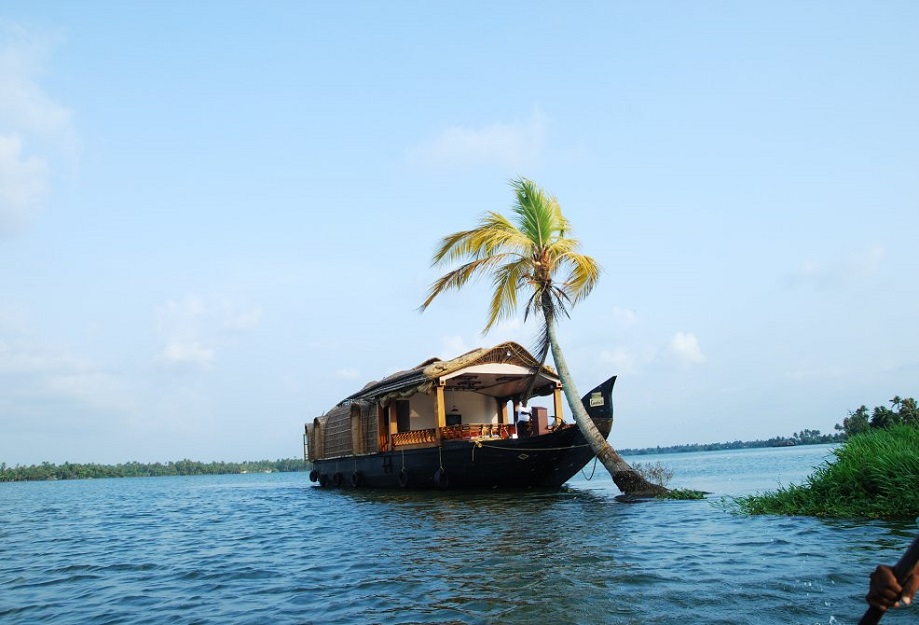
[408, 111, 546, 171]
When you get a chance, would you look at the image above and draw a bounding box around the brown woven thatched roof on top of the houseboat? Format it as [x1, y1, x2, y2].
[341, 341, 558, 404]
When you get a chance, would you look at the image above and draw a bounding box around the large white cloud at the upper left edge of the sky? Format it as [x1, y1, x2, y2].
[0, 22, 77, 234]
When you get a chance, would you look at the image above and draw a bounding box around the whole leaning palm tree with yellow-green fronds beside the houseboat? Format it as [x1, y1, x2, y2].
[421, 178, 666, 496]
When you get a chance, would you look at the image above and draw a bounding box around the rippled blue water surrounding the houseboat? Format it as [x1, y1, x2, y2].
[0, 446, 916, 625]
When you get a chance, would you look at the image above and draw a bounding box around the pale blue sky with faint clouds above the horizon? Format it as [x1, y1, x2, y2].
[0, 0, 919, 465]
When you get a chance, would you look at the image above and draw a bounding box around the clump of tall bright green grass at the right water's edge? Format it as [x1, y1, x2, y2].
[735, 425, 919, 519]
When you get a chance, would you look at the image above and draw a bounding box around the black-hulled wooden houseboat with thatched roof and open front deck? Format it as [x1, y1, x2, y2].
[303, 342, 616, 489]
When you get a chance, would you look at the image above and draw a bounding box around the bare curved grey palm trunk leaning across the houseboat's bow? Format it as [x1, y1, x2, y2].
[546, 318, 667, 497]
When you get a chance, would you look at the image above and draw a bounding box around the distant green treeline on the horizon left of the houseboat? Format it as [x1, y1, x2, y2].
[0, 459, 308, 482]
